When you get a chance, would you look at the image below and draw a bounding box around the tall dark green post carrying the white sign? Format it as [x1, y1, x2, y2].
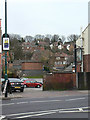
[5, 0, 8, 97]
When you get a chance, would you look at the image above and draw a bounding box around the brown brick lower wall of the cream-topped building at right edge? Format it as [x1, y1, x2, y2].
[83, 54, 90, 72]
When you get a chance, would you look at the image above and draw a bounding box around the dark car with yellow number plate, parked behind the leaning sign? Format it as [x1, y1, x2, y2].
[1, 78, 24, 92]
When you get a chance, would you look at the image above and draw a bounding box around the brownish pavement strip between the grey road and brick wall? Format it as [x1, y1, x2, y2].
[0, 88, 89, 100]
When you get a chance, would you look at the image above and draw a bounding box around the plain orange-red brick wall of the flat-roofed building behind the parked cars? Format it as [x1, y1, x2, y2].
[22, 62, 43, 70]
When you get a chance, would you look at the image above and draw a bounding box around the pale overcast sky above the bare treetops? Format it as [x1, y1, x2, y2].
[0, 0, 89, 37]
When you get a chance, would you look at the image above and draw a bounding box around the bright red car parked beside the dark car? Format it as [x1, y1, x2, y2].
[23, 80, 42, 88]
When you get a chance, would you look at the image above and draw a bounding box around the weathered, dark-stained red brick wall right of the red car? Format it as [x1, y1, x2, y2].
[43, 73, 76, 90]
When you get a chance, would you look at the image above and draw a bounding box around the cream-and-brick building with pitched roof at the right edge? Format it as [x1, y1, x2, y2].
[76, 24, 90, 72]
